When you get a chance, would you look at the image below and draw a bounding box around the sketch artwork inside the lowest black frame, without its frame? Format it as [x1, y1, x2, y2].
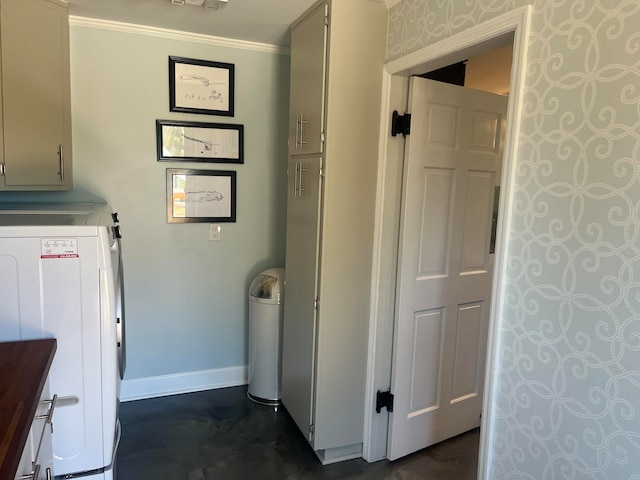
[173, 175, 231, 217]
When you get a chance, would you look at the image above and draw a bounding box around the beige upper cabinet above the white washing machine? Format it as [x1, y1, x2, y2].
[0, 0, 72, 190]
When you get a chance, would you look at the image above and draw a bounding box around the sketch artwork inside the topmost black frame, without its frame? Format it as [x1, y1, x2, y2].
[175, 63, 229, 111]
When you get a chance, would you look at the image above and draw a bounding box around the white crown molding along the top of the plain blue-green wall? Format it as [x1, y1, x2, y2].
[69, 15, 290, 55]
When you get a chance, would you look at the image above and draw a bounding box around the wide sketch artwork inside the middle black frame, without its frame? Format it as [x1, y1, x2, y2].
[162, 125, 240, 159]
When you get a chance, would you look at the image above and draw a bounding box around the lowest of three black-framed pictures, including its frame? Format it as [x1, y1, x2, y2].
[167, 168, 236, 223]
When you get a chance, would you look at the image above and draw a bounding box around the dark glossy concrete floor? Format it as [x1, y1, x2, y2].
[116, 387, 479, 480]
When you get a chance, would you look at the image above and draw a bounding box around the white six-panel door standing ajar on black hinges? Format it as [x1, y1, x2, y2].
[387, 77, 507, 460]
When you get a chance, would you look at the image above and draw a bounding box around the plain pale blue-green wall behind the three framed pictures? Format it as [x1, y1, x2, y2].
[0, 26, 289, 387]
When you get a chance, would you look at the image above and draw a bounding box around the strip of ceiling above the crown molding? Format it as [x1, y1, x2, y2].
[67, 0, 316, 46]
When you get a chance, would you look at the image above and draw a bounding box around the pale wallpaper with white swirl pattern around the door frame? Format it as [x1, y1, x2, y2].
[389, 0, 640, 480]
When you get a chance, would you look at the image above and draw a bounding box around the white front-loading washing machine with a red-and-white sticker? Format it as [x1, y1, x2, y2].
[0, 203, 125, 480]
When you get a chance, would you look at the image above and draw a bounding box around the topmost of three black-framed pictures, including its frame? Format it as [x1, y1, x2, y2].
[169, 56, 235, 117]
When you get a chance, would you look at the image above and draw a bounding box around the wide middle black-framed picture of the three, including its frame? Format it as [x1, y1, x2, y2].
[156, 120, 244, 163]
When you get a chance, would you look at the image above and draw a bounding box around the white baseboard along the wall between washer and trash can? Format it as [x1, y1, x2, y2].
[120, 366, 248, 402]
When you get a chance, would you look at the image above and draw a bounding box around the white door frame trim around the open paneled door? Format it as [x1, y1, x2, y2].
[363, 5, 533, 479]
